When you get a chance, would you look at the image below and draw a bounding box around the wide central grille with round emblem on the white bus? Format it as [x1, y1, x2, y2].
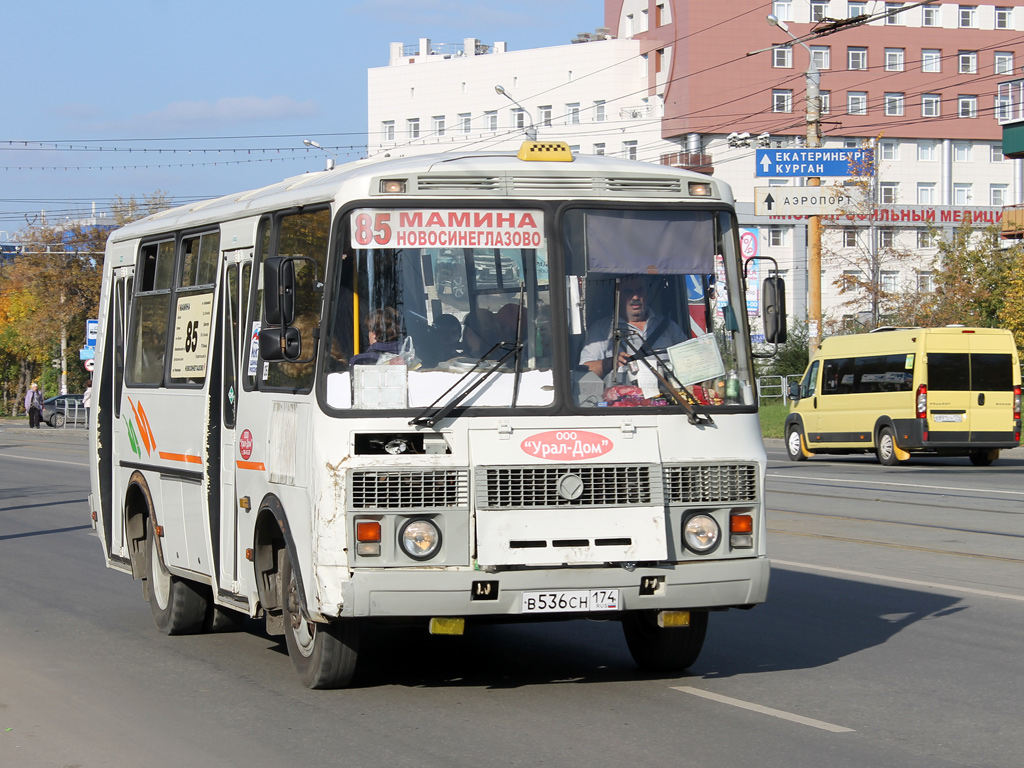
[477, 465, 663, 509]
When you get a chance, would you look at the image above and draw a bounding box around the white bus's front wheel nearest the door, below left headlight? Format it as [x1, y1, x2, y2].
[281, 547, 359, 688]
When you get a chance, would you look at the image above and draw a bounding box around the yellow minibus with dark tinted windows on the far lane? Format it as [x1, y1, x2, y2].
[785, 326, 1021, 466]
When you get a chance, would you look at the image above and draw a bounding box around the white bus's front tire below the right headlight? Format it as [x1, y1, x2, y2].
[623, 610, 708, 672]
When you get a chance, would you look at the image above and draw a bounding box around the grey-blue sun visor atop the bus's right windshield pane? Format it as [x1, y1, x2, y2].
[586, 211, 715, 274]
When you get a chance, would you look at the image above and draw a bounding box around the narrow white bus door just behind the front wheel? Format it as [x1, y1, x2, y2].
[213, 250, 253, 592]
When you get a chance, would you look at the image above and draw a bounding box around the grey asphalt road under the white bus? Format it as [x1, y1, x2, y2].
[0, 422, 1024, 768]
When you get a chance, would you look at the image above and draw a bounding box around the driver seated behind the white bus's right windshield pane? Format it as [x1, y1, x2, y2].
[580, 274, 689, 378]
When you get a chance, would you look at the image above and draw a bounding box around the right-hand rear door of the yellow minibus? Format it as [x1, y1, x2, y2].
[969, 334, 1014, 443]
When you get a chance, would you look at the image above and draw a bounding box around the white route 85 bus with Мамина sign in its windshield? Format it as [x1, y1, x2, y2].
[90, 142, 785, 687]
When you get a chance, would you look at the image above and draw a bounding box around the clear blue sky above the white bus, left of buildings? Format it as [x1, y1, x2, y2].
[0, 0, 604, 242]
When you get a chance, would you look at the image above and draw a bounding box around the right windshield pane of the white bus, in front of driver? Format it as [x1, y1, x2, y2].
[562, 204, 752, 408]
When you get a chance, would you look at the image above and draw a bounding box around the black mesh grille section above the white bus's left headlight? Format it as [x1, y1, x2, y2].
[349, 469, 469, 510]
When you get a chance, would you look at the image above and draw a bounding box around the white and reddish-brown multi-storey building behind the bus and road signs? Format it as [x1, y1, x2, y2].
[368, 0, 1024, 322]
